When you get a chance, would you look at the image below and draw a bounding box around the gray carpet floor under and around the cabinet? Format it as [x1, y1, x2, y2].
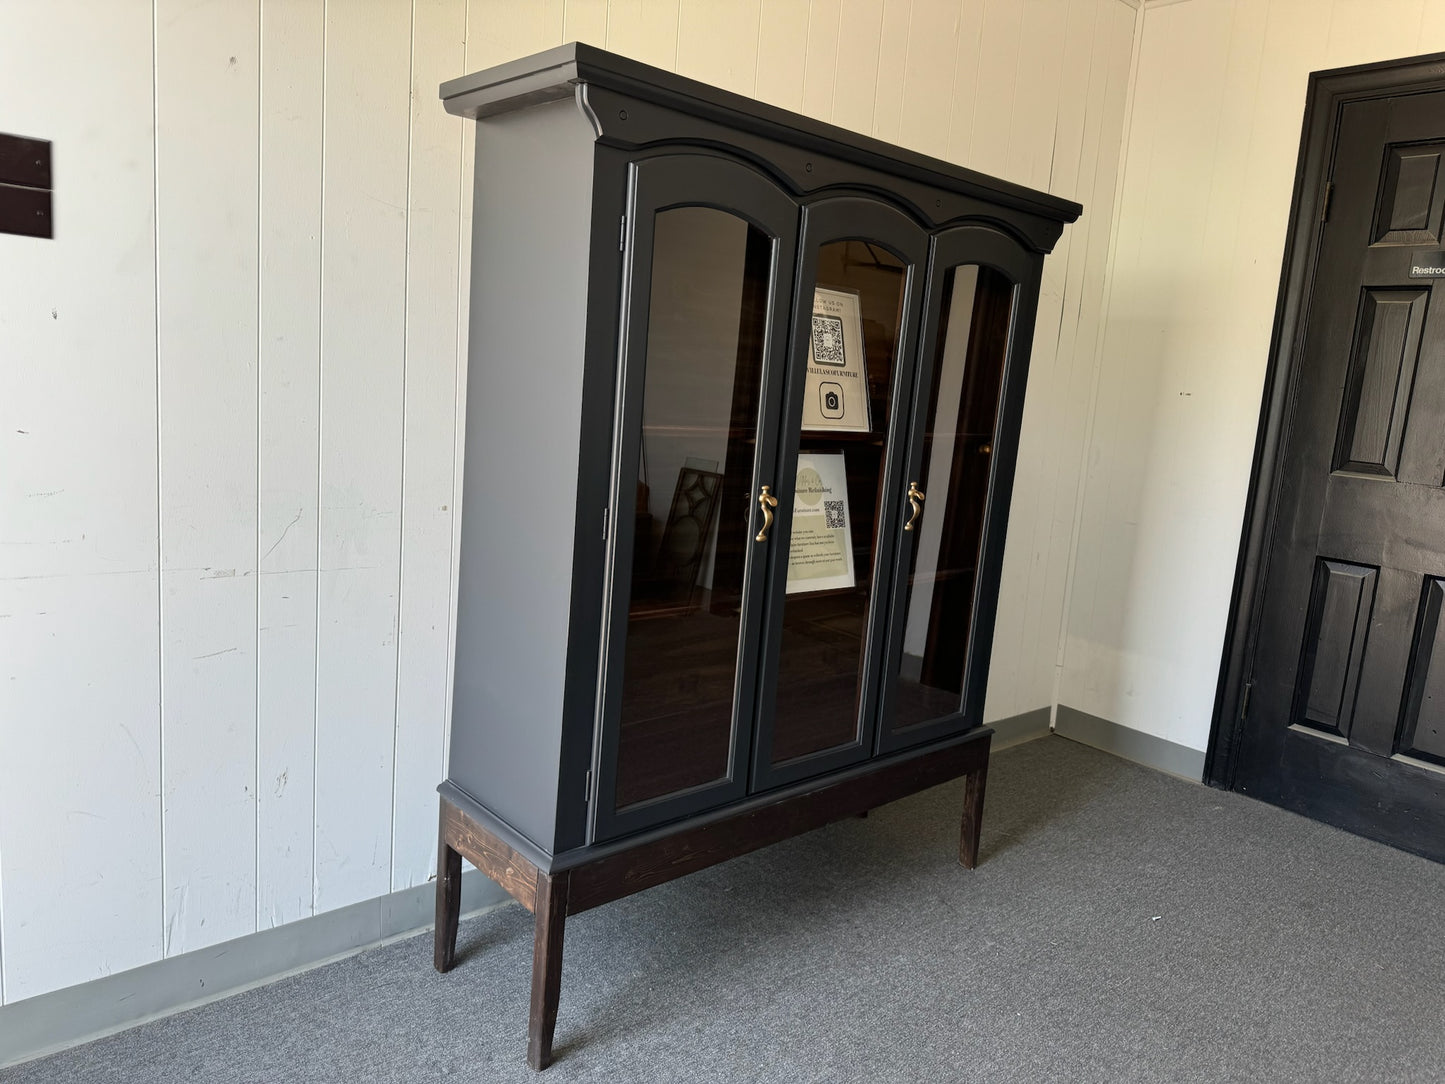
[0, 737, 1445, 1084]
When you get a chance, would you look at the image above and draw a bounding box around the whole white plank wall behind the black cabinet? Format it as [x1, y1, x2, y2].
[0, 0, 1138, 1003]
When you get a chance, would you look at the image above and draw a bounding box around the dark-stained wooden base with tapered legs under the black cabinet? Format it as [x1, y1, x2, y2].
[434, 731, 991, 1070]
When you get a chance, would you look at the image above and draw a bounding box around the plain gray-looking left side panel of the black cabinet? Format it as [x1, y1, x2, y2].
[448, 100, 601, 850]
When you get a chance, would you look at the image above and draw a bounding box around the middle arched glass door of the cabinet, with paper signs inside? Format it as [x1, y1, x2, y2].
[753, 197, 928, 789]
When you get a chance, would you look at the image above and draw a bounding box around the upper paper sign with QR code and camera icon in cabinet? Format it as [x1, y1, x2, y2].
[803, 286, 873, 432]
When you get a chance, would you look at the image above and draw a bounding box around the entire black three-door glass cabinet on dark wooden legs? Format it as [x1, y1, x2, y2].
[436, 45, 1081, 1068]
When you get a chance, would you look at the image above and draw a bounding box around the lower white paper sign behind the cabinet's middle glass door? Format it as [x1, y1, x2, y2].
[788, 452, 857, 594]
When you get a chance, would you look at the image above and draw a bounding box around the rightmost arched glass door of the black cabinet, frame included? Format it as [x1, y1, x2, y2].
[879, 227, 1036, 750]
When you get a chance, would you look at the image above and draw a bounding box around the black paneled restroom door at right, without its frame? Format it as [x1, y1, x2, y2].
[1234, 91, 1445, 860]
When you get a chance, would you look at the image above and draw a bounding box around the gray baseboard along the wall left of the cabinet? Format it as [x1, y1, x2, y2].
[0, 870, 507, 1068]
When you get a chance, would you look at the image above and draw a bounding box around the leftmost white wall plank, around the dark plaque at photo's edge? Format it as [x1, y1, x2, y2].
[0, 0, 162, 1002]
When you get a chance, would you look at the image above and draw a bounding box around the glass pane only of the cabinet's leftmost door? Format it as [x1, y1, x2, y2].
[616, 207, 773, 809]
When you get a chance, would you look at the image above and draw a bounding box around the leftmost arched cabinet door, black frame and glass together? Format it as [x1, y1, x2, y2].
[595, 153, 798, 838]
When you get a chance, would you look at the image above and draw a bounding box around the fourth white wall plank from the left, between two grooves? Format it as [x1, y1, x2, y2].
[315, 3, 412, 911]
